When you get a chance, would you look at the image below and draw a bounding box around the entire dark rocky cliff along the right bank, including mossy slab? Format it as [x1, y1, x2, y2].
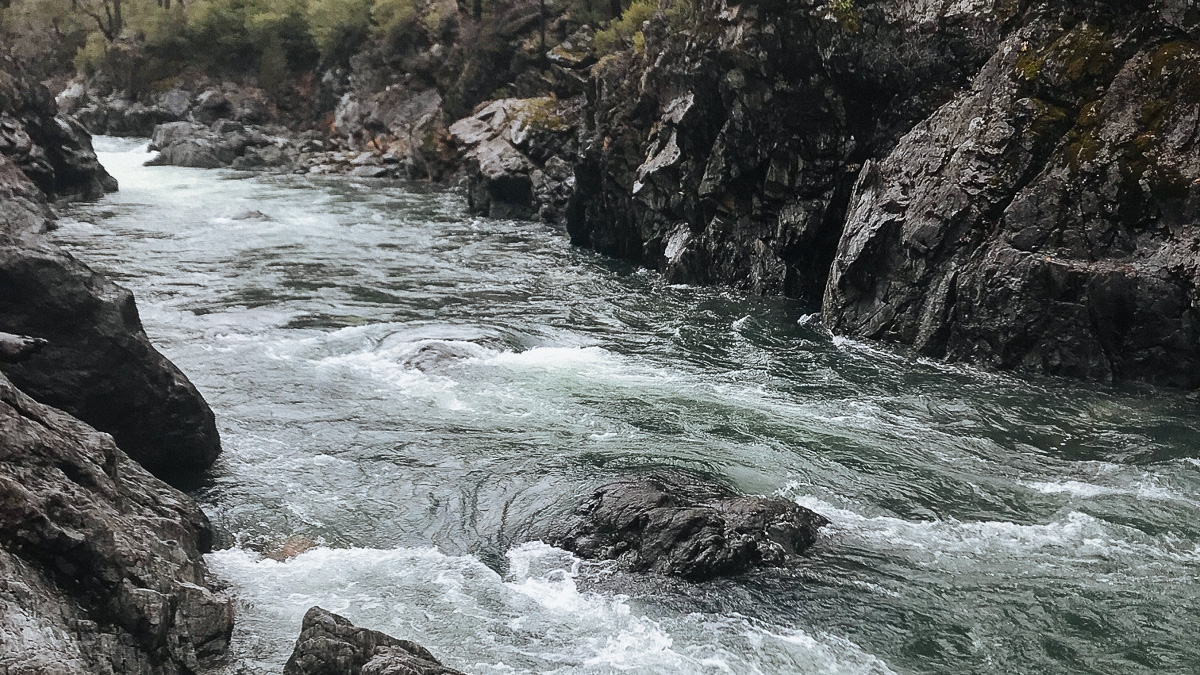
[568, 0, 1200, 387]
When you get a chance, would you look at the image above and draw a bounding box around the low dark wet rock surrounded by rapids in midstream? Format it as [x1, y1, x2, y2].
[551, 477, 828, 581]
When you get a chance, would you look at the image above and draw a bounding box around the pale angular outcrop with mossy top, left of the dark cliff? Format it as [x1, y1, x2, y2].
[450, 97, 583, 221]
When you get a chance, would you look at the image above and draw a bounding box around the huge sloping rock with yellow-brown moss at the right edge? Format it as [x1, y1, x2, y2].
[824, 2, 1200, 388]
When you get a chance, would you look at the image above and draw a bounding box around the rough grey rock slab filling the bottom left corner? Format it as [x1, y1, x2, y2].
[0, 367, 233, 675]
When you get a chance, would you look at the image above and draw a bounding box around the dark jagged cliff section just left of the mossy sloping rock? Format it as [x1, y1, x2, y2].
[568, 0, 1015, 301]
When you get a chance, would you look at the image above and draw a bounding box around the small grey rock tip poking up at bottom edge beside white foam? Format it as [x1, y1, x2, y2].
[283, 607, 462, 675]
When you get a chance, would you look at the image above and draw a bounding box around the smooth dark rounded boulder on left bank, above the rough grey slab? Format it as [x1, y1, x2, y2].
[0, 151, 221, 478]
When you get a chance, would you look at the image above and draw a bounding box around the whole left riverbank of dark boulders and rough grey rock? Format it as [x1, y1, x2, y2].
[0, 48, 233, 675]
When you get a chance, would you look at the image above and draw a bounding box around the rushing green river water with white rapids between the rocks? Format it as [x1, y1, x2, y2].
[56, 139, 1200, 674]
